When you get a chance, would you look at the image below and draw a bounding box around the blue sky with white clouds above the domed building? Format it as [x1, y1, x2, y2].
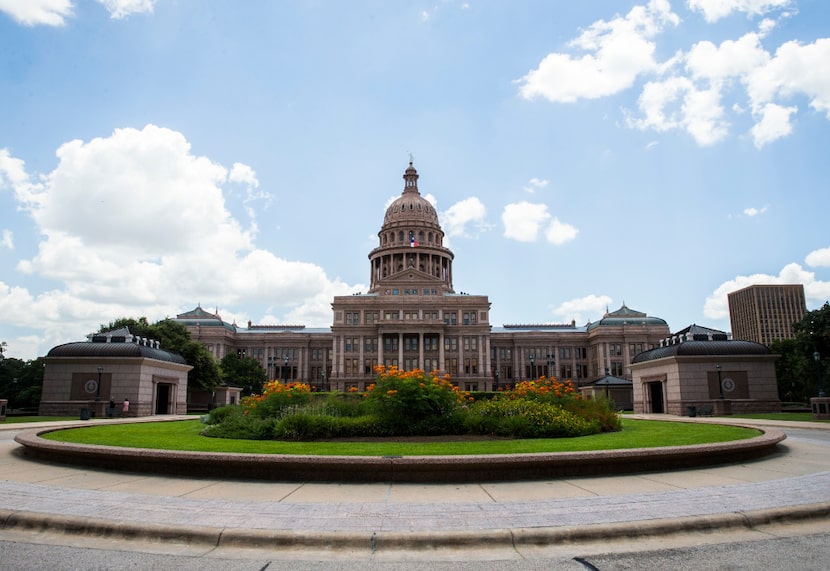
[0, 0, 830, 359]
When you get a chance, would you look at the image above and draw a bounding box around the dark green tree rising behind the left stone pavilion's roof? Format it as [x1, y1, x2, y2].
[98, 317, 221, 391]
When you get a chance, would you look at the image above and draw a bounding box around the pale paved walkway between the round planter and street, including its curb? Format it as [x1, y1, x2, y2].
[0, 415, 830, 557]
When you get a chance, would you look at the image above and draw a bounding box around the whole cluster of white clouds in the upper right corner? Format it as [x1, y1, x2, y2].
[518, 0, 830, 149]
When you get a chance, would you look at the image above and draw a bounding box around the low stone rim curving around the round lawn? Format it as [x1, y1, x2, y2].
[15, 423, 786, 483]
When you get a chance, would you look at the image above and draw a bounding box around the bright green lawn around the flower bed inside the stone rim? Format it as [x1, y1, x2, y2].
[44, 419, 760, 456]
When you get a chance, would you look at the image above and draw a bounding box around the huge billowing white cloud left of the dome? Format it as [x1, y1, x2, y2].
[0, 125, 365, 358]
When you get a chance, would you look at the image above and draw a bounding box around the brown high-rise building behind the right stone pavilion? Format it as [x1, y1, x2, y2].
[728, 284, 807, 346]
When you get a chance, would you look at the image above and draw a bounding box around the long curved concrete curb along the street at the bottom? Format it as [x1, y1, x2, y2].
[0, 502, 830, 553]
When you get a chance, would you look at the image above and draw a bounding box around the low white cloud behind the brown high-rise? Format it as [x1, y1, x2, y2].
[703, 260, 830, 320]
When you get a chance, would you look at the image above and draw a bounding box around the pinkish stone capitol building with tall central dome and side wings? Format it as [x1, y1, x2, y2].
[177, 163, 669, 391]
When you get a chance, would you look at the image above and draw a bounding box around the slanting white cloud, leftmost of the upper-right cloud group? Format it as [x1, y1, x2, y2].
[518, 0, 680, 103]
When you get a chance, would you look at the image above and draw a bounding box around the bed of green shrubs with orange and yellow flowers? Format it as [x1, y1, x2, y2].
[203, 367, 620, 440]
